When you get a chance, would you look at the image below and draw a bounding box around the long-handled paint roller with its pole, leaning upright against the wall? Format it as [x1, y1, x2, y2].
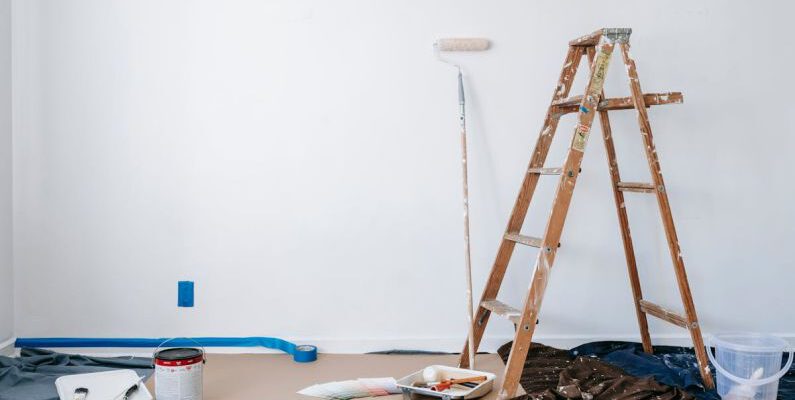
[433, 38, 491, 369]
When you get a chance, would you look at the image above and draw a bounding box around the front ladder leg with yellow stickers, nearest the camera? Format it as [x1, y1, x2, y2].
[499, 36, 614, 399]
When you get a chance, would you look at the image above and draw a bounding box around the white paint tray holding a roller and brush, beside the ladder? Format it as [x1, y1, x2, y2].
[397, 365, 497, 400]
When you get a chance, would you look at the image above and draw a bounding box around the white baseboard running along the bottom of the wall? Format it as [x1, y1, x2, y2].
[18, 333, 795, 357]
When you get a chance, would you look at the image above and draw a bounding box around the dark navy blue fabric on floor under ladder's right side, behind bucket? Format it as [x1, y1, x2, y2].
[570, 342, 795, 400]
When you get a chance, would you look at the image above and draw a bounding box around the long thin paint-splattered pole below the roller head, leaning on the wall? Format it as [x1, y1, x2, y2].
[458, 68, 475, 369]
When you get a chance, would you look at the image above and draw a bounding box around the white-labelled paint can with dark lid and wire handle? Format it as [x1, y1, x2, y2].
[154, 347, 205, 400]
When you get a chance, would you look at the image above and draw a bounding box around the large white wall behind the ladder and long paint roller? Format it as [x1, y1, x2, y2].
[13, 0, 795, 351]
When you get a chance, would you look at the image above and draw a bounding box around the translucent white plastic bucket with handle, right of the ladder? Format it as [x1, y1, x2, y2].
[707, 333, 792, 400]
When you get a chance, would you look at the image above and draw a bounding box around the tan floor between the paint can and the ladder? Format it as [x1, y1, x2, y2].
[147, 354, 524, 400]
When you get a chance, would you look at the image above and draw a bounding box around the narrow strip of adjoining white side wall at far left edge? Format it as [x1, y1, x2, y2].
[0, 0, 14, 351]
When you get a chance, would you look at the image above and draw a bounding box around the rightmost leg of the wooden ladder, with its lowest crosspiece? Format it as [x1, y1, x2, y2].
[620, 43, 714, 389]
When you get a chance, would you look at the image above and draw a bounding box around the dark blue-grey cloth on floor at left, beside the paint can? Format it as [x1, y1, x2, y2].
[0, 348, 154, 400]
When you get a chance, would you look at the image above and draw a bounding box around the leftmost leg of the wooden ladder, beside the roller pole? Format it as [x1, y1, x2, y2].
[459, 47, 584, 368]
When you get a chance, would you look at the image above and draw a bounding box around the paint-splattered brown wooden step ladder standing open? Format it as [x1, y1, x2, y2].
[460, 28, 714, 399]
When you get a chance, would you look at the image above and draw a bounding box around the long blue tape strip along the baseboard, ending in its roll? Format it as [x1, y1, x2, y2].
[14, 337, 317, 362]
